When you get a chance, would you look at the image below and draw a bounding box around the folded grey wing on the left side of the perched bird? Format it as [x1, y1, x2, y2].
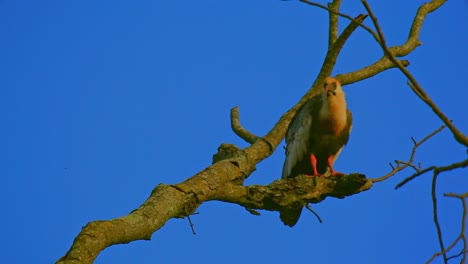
[282, 98, 318, 179]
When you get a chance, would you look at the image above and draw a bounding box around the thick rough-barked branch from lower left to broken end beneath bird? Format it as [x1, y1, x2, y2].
[58, 173, 372, 263]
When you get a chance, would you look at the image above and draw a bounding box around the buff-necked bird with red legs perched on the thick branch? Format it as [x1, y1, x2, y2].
[280, 77, 353, 227]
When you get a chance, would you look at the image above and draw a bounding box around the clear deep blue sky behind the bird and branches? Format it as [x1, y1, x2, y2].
[0, 0, 468, 263]
